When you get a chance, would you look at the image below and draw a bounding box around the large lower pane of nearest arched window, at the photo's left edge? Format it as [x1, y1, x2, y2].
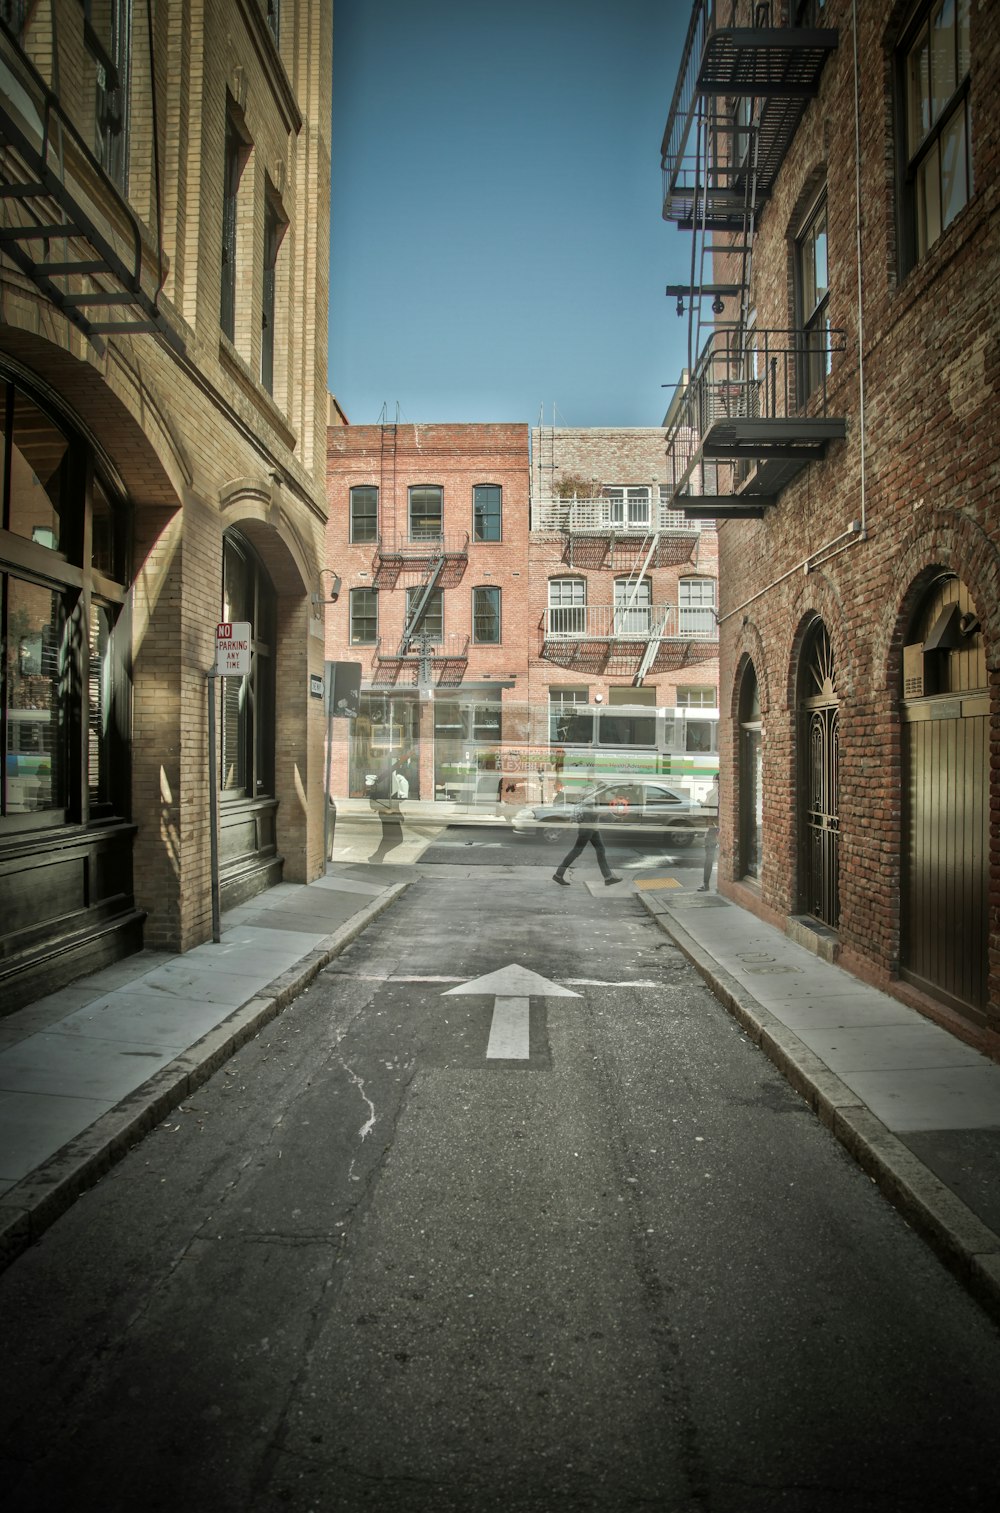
[3, 578, 67, 814]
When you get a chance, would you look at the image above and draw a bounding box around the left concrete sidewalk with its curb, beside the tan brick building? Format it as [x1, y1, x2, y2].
[0, 864, 413, 1268]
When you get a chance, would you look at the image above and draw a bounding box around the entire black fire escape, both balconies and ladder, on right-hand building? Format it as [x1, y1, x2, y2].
[661, 0, 846, 519]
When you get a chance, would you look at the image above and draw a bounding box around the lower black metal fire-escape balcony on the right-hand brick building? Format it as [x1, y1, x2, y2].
[667, 330, 847, 519]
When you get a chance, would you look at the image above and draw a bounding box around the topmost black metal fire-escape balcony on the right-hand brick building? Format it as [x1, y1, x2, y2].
[661, 0, 838, 231]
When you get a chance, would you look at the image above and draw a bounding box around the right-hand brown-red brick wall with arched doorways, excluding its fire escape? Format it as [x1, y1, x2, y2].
[664, 0, 1000, 1055]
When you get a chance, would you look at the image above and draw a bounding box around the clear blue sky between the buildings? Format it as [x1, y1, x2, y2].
[330, 0, 690, 425]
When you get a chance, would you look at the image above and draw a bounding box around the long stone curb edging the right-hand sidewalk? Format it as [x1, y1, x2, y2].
[640, 894, 1000, 1324]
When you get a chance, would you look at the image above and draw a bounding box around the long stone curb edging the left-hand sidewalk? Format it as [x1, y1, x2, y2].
[0, 879, 413, 1271]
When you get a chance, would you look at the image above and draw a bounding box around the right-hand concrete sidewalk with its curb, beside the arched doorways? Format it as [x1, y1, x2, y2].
[638, 879, 1000, 1321]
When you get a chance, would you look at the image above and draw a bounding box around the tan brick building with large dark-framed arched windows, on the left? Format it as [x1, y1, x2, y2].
[0, 0, 331, 1008]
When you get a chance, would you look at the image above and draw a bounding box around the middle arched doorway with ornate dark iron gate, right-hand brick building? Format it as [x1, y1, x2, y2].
[799, 620, 840, 929]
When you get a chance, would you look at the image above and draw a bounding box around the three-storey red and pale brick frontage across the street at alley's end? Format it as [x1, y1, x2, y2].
[327, 424, 717, 802]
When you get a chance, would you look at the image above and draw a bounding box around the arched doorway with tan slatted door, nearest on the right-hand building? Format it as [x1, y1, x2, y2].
[900, 575, 989, 1021]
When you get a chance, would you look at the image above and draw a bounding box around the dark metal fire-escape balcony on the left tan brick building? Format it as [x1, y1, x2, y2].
[0, 29, 183, 350]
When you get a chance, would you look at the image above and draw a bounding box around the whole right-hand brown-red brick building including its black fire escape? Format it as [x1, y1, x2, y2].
[663, 0, 1000, 1055]
